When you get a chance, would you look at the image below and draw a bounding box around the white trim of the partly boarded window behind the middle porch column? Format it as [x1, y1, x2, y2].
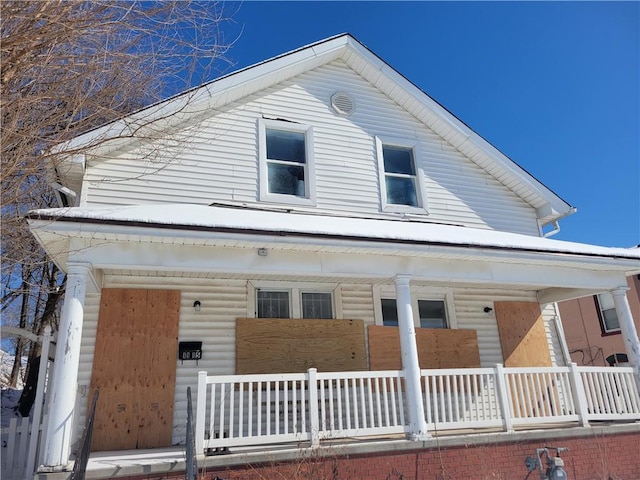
[373, 285, 458, 330]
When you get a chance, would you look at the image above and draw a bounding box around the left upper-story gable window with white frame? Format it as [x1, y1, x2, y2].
[258, 119, 315, 205]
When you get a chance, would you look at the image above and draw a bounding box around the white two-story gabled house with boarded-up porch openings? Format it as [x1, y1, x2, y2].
[28, 35, 640, 471]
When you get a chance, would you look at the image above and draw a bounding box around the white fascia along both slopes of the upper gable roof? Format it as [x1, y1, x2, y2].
[50, 34, 572, 223]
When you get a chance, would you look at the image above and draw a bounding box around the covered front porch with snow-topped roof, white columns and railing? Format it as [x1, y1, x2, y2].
[25, 206, 640, 471]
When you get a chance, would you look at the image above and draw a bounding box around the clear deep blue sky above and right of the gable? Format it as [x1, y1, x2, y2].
[219, 1, 640, 247]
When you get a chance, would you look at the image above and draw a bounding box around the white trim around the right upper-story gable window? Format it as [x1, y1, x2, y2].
[375, 135, 429, 214]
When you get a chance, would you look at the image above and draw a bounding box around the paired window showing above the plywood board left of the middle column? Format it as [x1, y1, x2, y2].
[255, 285, 336, 319]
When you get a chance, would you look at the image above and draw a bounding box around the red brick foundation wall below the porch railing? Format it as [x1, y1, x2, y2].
[124, 427, 640, 480]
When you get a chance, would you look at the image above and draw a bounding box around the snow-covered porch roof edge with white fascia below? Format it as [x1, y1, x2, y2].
[29, 205, 640, 274]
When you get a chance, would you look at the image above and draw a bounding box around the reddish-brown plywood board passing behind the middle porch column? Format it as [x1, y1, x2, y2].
[368, 325, 480, 370]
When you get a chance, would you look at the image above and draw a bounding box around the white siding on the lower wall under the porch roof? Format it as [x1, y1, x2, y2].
[77, 274, 564, 443]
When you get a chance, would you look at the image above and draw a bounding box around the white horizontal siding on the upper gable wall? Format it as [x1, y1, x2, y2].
[81, 61, 539, 236]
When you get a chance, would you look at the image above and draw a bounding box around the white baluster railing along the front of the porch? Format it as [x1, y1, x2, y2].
[195, 364, 640, 452]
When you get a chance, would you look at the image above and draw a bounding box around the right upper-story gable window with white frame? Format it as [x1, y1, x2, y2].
[376, 137, 426, 213]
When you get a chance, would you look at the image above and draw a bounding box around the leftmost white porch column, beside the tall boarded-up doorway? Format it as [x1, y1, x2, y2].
[40, 263, 91, 472]
